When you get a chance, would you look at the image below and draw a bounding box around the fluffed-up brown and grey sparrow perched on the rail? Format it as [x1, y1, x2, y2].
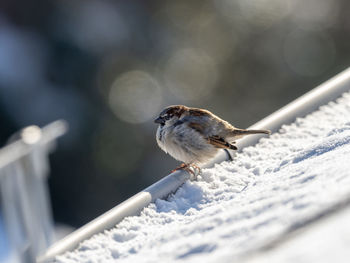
[154, 105, 271, 173]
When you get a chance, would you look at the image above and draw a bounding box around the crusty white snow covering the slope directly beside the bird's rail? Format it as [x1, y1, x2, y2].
[56, 93, 350, 262]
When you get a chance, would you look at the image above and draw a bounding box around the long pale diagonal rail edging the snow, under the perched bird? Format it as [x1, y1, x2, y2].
[38, 68, 350, 262]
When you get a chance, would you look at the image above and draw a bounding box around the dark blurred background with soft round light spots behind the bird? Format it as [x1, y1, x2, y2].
[0, 0, 350, 231]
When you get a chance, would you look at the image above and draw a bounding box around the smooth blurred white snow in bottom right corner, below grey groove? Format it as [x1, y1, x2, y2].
[245, 207, 350, 263]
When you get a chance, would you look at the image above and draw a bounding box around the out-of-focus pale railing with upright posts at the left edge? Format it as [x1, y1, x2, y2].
[0, 121, 66, 262]
